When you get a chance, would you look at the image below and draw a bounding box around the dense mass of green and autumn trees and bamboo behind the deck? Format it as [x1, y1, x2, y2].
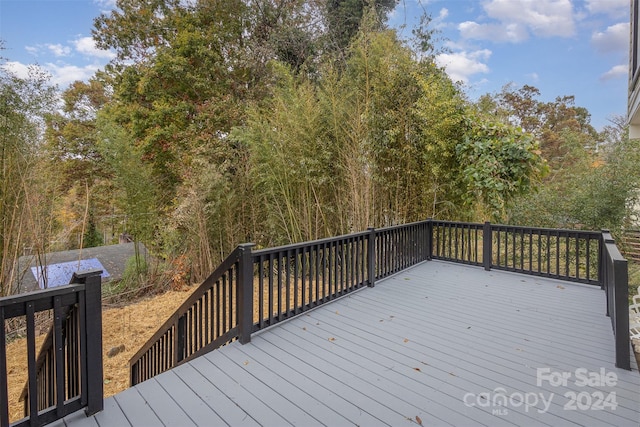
[0, 0, 638, 292]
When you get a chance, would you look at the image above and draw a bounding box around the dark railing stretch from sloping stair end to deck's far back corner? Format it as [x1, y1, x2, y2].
[129, 222, 429, 385]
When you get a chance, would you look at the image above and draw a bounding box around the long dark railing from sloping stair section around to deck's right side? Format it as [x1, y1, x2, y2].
[130, 219, 630, 385]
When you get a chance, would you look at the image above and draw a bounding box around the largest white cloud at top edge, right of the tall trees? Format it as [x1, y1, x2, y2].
[459, 0, 576, 43]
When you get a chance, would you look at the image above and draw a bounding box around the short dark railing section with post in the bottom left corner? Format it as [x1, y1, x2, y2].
[0, 270, 103, 426]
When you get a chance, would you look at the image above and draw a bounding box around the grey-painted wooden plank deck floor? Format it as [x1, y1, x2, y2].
[53, 261, 640, 427]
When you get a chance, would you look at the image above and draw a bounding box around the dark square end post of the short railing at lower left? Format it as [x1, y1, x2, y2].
[73, 270, 104, 416]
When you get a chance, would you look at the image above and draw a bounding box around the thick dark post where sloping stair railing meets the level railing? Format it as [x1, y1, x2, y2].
[238, 243, 255, 344]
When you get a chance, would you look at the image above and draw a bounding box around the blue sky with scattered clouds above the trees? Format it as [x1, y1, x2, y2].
[0, 0, 629, 128]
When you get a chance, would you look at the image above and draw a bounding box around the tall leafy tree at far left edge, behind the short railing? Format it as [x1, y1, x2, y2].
[0, 51, 55, 295]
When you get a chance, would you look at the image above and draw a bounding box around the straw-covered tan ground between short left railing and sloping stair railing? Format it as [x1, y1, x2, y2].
[7, 286, 197, 422]
